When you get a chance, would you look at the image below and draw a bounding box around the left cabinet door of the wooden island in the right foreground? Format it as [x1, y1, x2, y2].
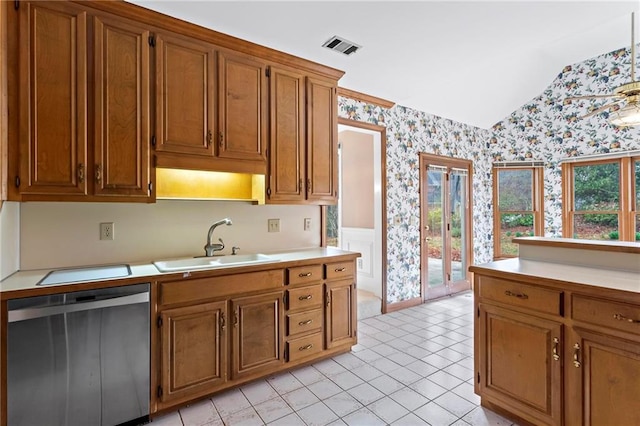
[478, 305, 563, 425]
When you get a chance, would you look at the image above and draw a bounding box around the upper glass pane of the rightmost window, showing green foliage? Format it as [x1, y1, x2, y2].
[573, 163, 620, 210]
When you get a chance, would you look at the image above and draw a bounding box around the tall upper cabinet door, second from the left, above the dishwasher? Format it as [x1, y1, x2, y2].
[93, 16, 150, 198]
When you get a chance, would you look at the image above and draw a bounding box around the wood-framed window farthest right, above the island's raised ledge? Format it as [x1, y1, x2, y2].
[562, 157, 640, 241]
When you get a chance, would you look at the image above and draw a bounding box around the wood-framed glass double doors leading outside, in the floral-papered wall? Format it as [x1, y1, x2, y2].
[420, 154, 472, 300]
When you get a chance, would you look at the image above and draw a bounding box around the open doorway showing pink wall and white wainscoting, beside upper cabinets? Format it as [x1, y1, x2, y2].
[323, 119, 387, 319]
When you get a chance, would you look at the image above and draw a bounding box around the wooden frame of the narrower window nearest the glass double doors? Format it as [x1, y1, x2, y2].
[492, 164, 544, 260]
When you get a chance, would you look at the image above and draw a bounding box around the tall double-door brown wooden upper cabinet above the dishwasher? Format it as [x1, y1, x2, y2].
[15, 2, 152, 201]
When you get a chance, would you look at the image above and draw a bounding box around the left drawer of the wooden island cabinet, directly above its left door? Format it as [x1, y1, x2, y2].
[478, 276, 562, 315]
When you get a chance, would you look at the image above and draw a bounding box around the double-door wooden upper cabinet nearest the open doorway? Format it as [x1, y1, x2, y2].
[267, 67, 338, 204]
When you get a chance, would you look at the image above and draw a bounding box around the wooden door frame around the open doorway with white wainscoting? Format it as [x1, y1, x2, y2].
[320, 117, 387, 314]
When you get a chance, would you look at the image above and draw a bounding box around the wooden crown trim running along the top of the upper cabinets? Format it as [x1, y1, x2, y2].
[71, 0, 344, 80]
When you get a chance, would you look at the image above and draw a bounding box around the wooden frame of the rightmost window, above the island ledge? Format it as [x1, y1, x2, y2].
[562, 156, 640, 242]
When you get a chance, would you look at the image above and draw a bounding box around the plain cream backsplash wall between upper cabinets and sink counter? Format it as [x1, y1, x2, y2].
[20, 200, 320, 270]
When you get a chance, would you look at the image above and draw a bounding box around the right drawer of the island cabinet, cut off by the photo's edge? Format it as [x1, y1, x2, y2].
[571, 294, 640, 334]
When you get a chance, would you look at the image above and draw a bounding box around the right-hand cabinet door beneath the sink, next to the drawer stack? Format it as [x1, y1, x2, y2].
[231, 291, 284, 379]
